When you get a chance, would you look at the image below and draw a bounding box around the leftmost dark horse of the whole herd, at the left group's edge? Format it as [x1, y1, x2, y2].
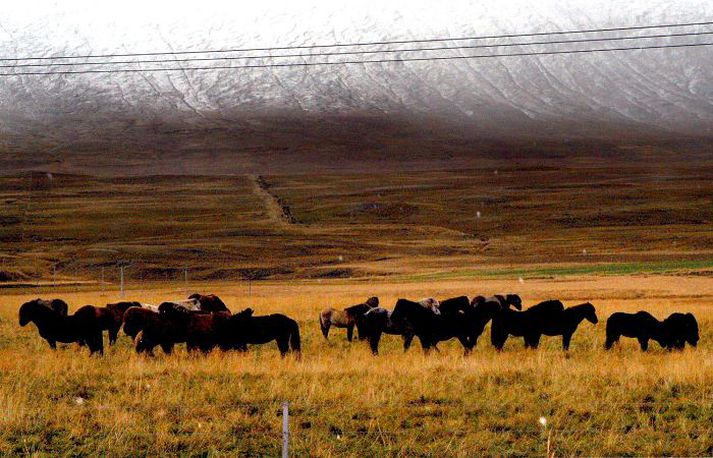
[19, 301, 104, 355]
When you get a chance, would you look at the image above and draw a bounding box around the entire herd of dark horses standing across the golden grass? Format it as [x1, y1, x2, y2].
[19, 294, 699, 357]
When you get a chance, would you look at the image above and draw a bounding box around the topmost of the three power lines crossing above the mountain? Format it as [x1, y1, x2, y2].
[0, 21, 713, 62]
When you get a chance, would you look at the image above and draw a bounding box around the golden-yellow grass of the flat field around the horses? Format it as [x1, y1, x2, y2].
[0, 275, 713, 456]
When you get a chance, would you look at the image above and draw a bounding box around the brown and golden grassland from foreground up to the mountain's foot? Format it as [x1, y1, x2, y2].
[0, 154, 713, 457]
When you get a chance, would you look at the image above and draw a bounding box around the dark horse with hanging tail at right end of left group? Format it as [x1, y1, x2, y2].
[218, 308, 301, 358]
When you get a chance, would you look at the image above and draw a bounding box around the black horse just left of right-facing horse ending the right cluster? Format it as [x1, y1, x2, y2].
[490, 300, 564, 350]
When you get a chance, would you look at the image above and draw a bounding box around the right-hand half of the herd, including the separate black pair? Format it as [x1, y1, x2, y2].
[319, 294, 700, 355]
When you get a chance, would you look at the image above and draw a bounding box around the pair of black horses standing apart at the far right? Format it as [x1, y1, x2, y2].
[604, 311, 699, 351]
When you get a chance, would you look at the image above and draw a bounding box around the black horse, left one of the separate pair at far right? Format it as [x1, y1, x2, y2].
[604, 310, 666, 351]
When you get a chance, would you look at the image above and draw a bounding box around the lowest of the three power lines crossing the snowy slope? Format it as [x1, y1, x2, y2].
[0, 42, 713, 76]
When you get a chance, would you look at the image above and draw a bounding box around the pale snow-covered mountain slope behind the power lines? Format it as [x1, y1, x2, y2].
[0, 0, 713, 158]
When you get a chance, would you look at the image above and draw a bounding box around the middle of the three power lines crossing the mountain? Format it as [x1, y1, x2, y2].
[0, 30, 713, 68]
